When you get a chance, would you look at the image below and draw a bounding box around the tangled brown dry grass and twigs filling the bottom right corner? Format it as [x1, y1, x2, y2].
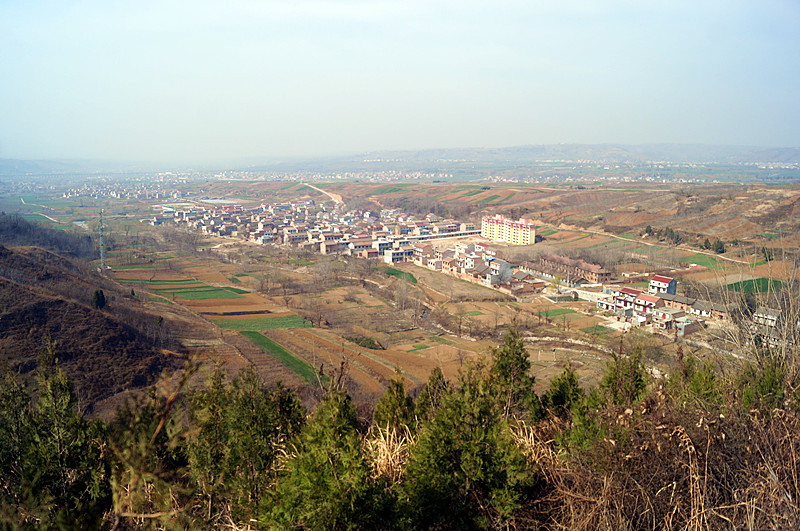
[512, 393, 800, 531]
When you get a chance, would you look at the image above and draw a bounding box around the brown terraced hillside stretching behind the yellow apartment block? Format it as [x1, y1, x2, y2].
[310, 183, 800, 240]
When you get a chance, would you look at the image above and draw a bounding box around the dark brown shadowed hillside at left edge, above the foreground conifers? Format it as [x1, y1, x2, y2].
[0, 246, 181, 409]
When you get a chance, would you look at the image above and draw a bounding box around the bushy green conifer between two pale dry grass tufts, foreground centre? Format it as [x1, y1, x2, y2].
[397, 367, 535, 529]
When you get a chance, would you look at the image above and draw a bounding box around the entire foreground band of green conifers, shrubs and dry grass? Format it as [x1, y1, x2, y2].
[0, 330, 800, 529]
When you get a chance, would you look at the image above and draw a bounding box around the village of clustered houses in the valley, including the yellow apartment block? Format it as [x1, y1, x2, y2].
[143, 199, 767, 336]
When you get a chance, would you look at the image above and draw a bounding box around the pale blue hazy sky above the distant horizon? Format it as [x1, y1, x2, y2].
[0, 0, 800, 162]
